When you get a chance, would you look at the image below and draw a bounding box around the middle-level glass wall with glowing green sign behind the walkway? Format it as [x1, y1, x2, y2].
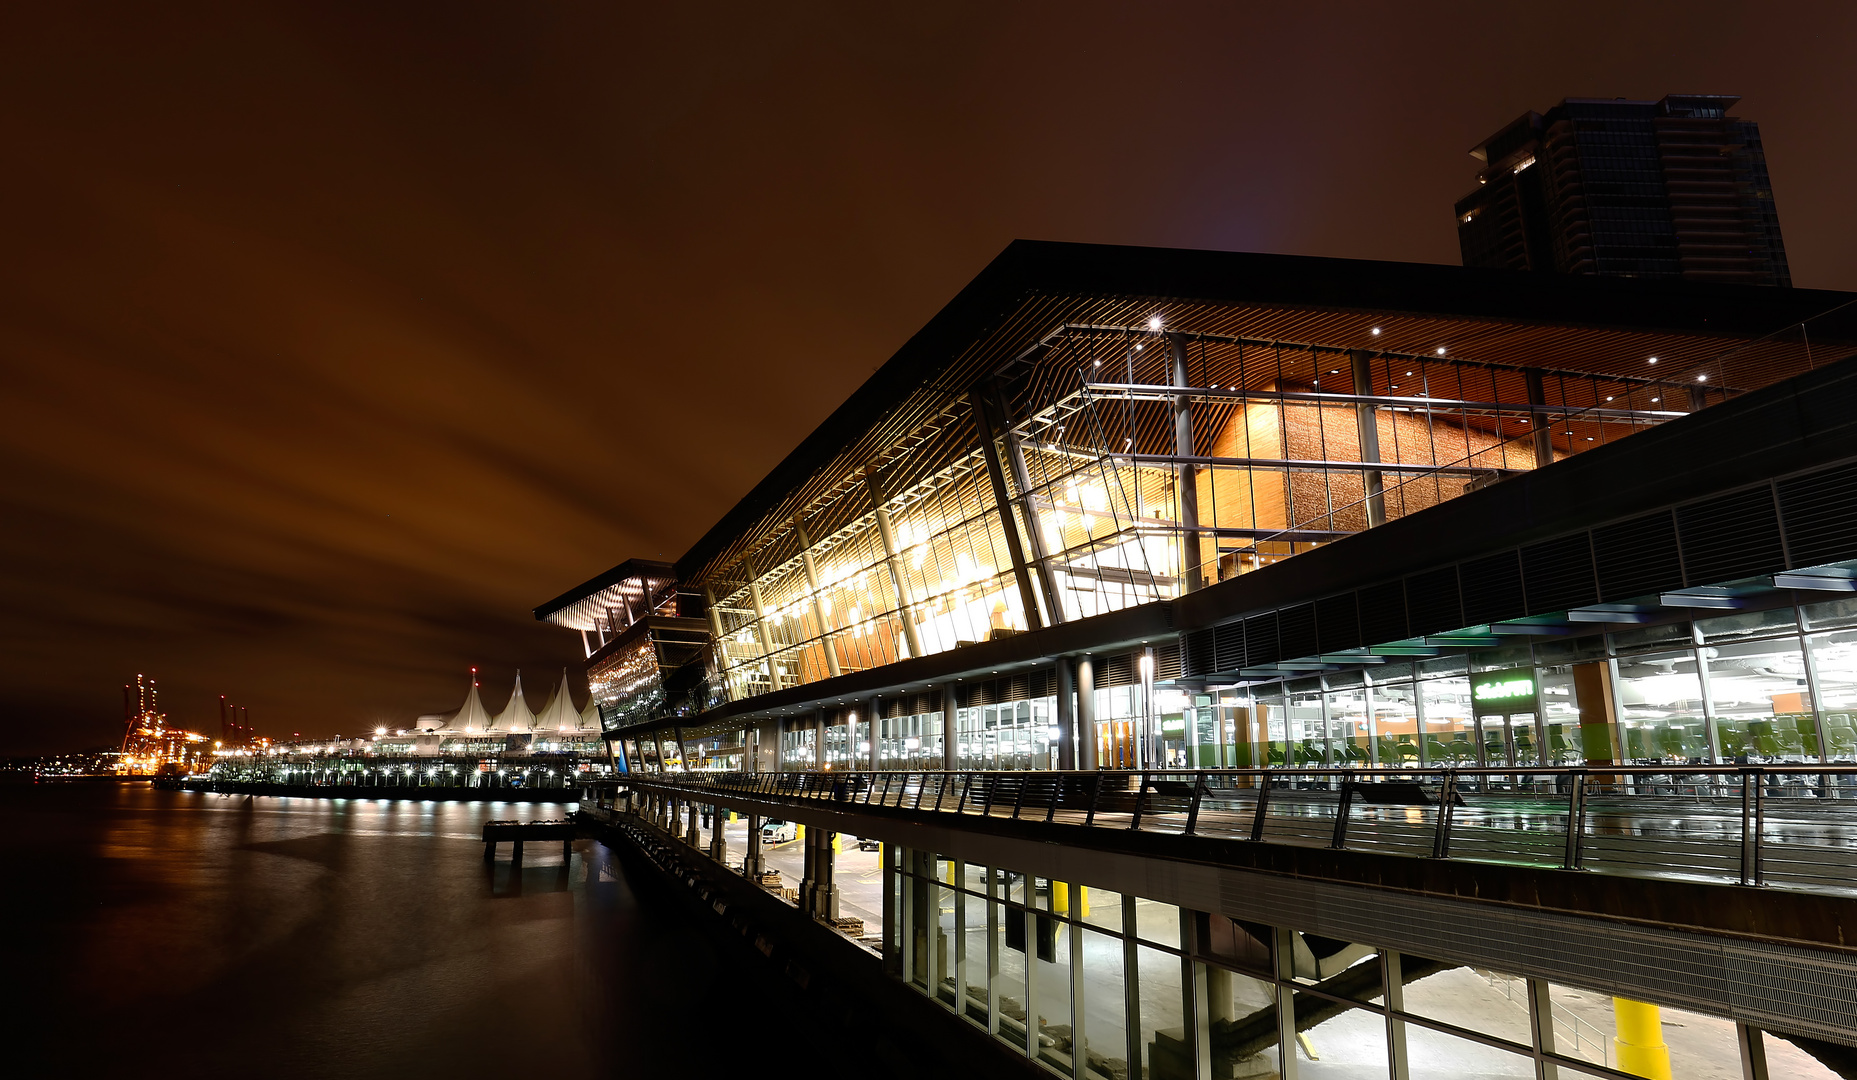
[1203, 599, 1857, 768]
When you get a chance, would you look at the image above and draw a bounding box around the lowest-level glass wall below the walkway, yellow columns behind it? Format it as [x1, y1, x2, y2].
[884, 848, 1831, 1080]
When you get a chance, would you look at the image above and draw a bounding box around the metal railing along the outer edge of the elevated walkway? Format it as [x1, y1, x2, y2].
[618, 765, 1857, 891]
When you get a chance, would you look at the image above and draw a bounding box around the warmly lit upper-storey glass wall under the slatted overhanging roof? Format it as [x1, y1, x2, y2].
[691, 327, 1708, 720]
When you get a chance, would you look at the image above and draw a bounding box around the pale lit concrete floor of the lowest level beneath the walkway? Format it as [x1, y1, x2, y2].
[679, 818, 1835, 1080]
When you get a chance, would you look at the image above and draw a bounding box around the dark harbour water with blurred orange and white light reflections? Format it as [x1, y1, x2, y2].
[0, 783, 843, 1078]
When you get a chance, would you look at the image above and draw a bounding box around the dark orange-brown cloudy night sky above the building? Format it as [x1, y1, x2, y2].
[0, 2, 1857, 753]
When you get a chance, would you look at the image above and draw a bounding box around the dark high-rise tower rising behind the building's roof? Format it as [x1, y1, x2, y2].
[1458, 95, 1792, 286]
